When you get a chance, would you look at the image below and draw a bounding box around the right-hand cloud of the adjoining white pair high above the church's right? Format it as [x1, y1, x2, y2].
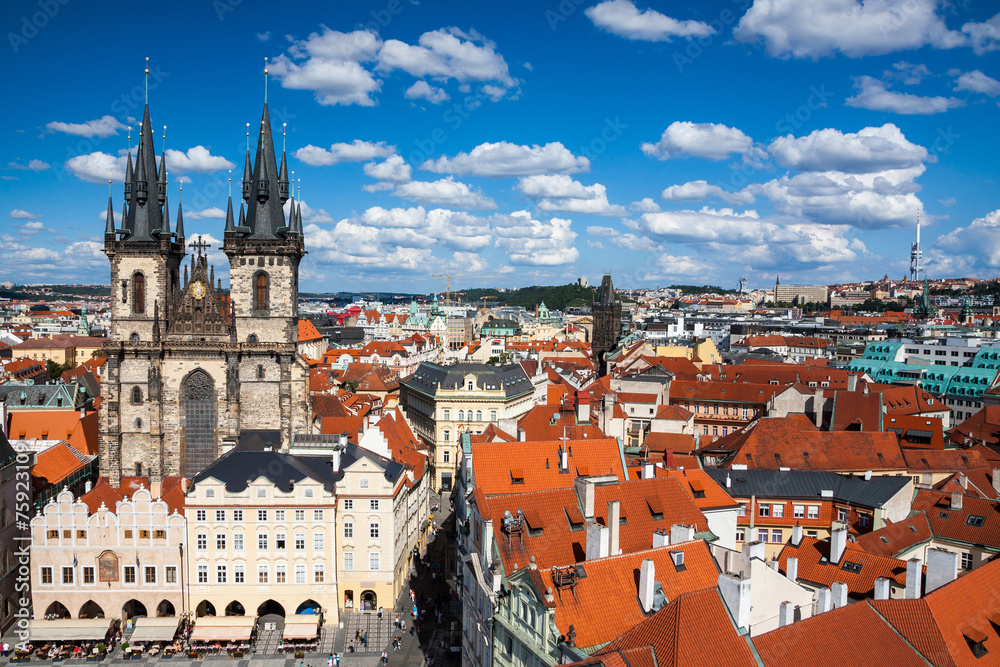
[378, 28, 517, 86]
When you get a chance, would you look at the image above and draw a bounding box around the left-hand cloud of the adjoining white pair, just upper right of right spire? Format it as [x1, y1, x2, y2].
[269, 27, 382, 106]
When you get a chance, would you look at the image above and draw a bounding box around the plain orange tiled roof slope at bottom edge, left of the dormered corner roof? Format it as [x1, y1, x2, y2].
[753, 603, 927, 667]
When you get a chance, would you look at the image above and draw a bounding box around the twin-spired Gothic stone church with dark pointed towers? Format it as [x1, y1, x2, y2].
[100, 104, 311, 486]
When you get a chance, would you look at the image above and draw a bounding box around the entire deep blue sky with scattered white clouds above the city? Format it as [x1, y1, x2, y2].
[0, 0, 1000, 293]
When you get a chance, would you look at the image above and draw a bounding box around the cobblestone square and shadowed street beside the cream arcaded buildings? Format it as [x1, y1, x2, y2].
[0, 493, 461, 667]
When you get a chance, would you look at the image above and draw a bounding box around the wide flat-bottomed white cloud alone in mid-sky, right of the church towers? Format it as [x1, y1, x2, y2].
[420, 141, 590, 178]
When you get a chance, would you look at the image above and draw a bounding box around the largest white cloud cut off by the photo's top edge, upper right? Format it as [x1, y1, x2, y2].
[733, 0, 967, 60]
